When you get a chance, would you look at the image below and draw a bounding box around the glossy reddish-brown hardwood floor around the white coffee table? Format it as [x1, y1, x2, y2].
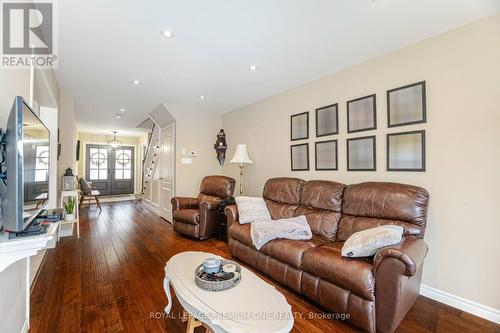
[30, 201, 500, 333]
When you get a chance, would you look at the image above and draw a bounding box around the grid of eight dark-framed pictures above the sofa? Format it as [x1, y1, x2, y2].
[290, 81, 427, 171]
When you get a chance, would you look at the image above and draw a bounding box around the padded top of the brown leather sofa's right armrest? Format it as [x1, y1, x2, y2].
[373, 236, 428, 276]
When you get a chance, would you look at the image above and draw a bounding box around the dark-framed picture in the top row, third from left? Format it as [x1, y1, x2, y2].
[347, 95, 377, 133]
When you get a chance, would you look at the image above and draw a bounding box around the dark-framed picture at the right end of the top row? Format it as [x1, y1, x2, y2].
[387, 81, 427, 127]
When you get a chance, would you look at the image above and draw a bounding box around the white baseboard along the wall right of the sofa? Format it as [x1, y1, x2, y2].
[420, 284, 500, 324]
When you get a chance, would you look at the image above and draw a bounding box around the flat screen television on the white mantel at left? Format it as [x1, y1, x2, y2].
[2, 96, 51, 231]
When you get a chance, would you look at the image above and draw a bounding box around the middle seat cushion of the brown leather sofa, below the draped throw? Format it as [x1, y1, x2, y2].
[260, 236, 327, 269]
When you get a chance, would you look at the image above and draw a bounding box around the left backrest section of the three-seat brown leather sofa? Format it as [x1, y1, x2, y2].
[262, 177, 305, 220]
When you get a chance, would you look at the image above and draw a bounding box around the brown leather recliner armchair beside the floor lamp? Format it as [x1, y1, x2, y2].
[172, 176, 235, 239]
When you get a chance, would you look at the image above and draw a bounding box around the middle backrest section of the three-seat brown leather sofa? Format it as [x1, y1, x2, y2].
[294, 180, 346, 240]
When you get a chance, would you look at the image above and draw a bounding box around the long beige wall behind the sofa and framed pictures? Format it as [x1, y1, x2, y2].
[223, 15, 500, 309]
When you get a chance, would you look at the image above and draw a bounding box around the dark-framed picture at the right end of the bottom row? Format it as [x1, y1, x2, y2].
[387, 130, 425, 171]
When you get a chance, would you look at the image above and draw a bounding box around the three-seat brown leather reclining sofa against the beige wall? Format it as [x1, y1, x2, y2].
[225, 178, 429, 333]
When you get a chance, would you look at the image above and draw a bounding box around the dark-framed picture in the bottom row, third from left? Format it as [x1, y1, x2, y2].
[347, 135, 377, 171]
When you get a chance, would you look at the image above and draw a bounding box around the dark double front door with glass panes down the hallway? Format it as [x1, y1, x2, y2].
[86, 145, 134, 195]
